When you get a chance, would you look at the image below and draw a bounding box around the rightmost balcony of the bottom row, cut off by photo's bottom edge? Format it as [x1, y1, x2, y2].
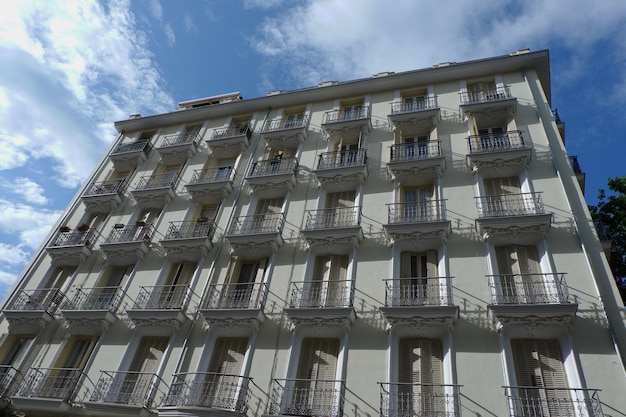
[504, 386, 604, 417]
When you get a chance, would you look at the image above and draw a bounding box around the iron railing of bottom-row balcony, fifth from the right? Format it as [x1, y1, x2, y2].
[89, 371, 167, 409]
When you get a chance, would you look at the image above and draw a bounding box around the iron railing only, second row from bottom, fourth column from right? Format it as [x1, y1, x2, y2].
[204, 282, 267, 310]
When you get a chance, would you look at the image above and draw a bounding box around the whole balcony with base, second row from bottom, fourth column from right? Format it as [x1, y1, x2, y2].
[200, 282, 267, 326]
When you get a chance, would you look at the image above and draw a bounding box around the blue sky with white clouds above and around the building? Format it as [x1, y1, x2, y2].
[0, 0, 626, 295]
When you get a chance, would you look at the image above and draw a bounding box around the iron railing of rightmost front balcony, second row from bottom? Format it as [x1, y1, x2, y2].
[488, 273, 572, 304]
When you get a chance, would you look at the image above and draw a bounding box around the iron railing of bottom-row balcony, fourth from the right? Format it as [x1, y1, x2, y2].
[163, 372, 252, 414]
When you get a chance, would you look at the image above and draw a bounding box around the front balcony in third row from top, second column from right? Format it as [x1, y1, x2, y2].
[383, 200, 451, 243]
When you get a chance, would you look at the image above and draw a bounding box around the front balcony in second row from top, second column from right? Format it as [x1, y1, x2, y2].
[387, 140, 446, 183]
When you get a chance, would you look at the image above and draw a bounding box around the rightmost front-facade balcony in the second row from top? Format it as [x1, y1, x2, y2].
[466, 131, 532, 176]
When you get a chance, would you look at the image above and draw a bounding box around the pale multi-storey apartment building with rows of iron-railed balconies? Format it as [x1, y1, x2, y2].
[0, 50, 626, 417]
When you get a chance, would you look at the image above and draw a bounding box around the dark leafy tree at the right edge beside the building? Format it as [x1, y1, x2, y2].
[589, 176, 626, 301]
